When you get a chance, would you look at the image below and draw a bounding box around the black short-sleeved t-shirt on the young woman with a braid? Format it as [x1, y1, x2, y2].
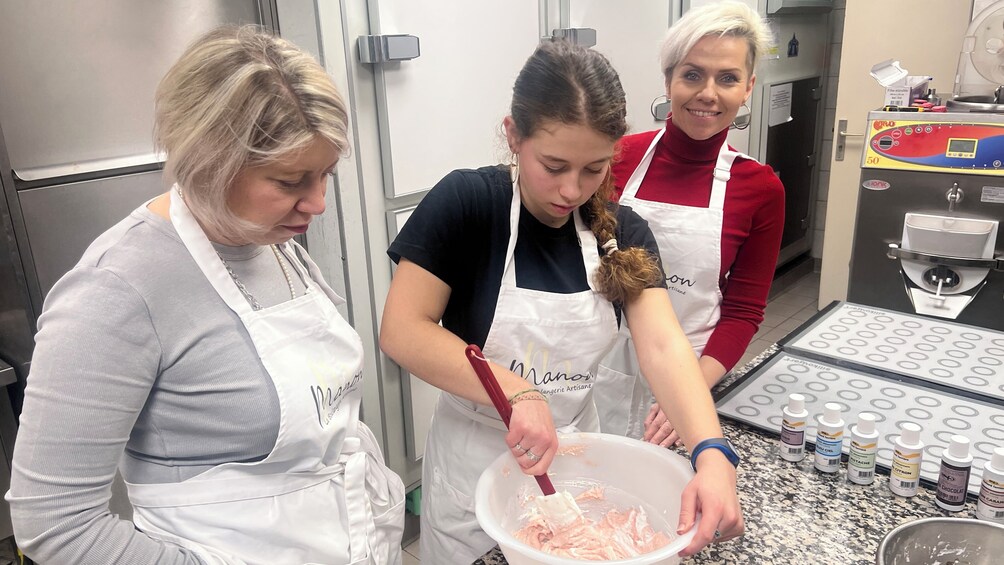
[388, 166, 666, 347]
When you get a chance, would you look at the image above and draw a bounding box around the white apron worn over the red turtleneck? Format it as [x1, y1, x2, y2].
[595, 128, 745, 439]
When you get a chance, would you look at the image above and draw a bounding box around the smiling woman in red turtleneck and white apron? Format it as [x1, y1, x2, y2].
[594, 2, 784, 446]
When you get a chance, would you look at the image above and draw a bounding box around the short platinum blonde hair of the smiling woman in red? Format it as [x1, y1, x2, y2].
[660, 2, 773, 80]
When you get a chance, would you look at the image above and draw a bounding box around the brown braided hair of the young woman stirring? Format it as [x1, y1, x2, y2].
[510, 40, 662, 304]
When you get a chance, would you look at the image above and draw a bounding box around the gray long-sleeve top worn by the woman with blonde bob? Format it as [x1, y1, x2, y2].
[7, 207, 303, 565]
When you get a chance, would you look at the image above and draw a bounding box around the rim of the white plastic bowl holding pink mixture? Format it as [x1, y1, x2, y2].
[474, 432, 701, 565]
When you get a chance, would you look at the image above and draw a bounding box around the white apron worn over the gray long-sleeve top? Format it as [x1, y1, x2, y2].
[128, 187, 405, 565]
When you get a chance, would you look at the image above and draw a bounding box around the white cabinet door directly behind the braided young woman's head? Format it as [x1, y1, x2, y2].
[370, 0, 539, 198]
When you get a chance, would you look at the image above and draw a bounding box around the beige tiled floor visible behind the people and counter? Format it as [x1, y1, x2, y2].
[403, 273, 819, 565]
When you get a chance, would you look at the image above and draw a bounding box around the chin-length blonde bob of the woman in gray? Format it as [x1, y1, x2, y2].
[155, 25, 348, 242]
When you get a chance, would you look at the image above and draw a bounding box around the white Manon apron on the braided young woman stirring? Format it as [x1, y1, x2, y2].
[422, 174, 616, 564]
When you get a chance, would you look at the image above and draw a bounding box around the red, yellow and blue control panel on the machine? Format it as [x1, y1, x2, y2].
[861, 114, 1004, 177]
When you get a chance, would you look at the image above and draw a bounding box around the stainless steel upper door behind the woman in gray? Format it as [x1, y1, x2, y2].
[0, 0, 260, 181]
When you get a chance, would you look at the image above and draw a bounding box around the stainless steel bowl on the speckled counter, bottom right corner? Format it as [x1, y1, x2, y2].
[875, 518, 1004, 565]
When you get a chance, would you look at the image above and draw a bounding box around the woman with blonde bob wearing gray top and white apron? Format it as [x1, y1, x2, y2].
[7, 27, 404, 565]
